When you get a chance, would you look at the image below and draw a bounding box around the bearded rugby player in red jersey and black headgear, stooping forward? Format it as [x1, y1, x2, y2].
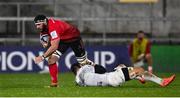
[34, 15, 91, 87]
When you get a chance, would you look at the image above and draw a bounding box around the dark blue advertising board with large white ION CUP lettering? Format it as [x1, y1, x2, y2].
[0, 46, 130, 72]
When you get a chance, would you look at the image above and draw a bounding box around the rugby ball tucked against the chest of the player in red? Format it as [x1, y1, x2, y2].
[40, 34, 49, 48]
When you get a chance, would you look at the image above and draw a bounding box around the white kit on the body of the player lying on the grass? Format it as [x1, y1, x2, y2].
[76, 65, 125, 86]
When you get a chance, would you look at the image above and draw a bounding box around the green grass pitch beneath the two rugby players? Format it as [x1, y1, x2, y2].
[0, 73, 180, 97]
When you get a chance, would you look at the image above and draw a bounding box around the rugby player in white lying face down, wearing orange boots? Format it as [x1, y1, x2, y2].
[71, 64, 175, 87]
